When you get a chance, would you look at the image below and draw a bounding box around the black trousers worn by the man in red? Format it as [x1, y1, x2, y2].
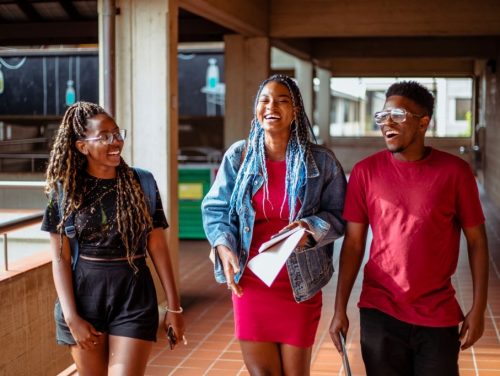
[360, 308, 460, 376]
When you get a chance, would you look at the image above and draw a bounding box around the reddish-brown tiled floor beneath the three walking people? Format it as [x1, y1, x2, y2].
[146, 191, 500, 376]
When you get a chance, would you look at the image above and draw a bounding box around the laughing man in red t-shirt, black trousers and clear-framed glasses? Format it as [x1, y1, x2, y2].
[330, 81, 488, 376]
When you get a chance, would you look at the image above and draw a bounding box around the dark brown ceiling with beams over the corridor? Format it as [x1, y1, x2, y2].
[0, 0, 500, 75]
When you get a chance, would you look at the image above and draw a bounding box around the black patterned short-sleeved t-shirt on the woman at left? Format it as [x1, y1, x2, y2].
[41, 174, 168, 257]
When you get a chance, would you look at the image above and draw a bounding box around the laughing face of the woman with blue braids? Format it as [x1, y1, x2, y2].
[255, 81, 295, 141]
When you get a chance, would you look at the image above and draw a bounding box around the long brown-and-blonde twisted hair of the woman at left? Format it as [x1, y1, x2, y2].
[45, 102, 153, 267]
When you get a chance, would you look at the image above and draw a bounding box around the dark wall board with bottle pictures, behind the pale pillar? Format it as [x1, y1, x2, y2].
[0, 51, 225, 116]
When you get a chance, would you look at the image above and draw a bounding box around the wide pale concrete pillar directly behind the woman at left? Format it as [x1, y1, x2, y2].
[111, 0, 179, 297]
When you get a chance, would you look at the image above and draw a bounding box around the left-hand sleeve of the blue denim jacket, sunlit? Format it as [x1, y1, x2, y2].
[201, 140, 245, 261]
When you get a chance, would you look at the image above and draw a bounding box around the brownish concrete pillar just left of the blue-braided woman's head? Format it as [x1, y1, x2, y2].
[224, 34, 271, 148]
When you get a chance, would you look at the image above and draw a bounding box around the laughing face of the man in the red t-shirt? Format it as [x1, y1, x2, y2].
[381, 95, 430, 161]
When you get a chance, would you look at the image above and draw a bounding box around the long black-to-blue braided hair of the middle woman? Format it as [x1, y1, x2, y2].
[229, 74, 314, 222]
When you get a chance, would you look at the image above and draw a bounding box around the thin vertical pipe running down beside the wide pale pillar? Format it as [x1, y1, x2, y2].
[101, 0, 116, 116]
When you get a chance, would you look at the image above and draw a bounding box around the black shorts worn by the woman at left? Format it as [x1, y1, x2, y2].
[54, 258, 159, 345]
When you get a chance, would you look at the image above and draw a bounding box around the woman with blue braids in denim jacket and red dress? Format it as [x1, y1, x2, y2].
[202, 75, 346, 376]
